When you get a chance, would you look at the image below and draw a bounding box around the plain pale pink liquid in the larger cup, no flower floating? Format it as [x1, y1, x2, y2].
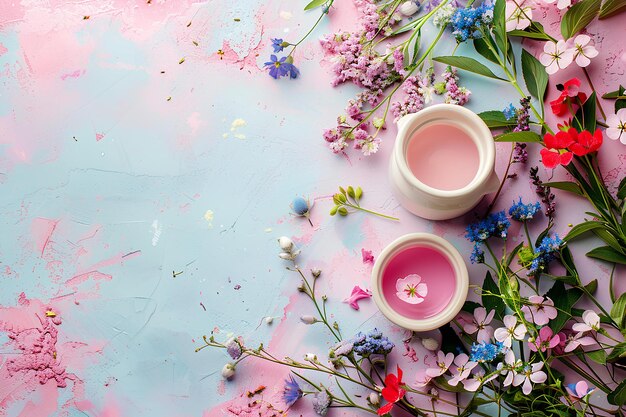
[406, 124, 480, 191]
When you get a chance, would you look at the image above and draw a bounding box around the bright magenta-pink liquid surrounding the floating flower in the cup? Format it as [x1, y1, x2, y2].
[382, 246, 456, 320]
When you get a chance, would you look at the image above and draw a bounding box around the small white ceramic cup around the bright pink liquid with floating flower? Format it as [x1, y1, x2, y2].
[371, 233, 469, 332]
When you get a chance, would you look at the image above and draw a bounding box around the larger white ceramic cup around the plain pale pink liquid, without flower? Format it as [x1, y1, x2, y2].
[389, 104, 500, 220]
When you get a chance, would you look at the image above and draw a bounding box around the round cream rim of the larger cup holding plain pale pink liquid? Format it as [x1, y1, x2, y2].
[393, 103, 496, 197]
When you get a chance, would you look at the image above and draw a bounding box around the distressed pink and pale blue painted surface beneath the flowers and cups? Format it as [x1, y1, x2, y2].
[0, 0, 626, 417]
